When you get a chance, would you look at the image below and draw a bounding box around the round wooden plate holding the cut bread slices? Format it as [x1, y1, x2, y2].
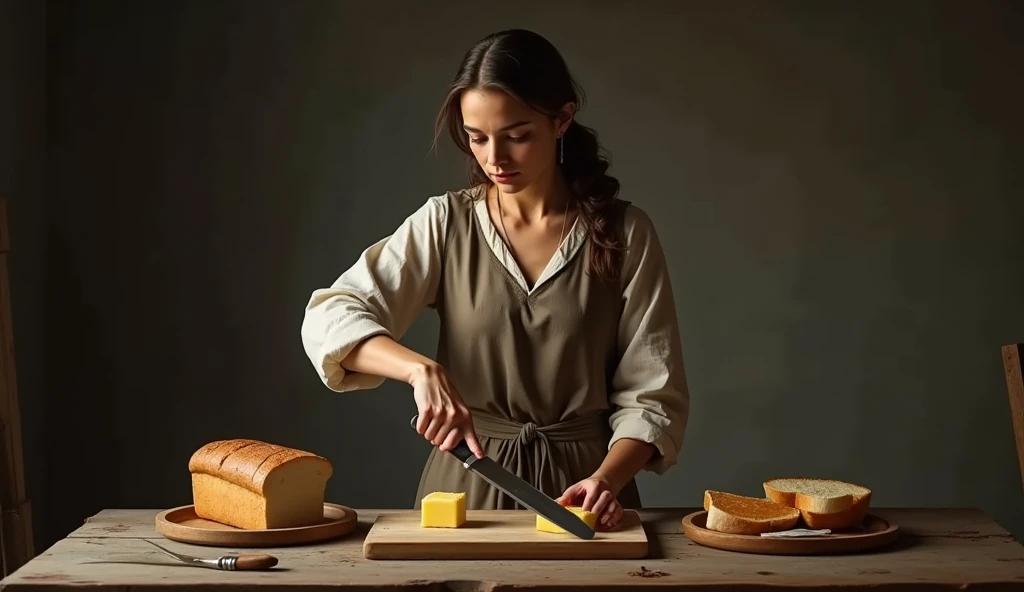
[682, 510, 899, 555]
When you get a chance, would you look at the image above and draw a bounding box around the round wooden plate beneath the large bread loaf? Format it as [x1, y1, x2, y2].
[157, 504, 358, 547]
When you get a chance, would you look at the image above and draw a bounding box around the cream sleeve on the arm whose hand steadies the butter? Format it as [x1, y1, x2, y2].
[608, 206, 690, 473]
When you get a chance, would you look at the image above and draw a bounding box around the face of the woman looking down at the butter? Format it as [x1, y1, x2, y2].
[462, 89, 571, 194]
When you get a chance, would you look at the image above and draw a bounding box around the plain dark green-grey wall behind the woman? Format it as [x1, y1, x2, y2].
[0, 0, 1024, 548]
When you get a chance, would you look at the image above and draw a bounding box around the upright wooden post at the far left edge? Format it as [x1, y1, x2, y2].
[0, 198, 35, 576]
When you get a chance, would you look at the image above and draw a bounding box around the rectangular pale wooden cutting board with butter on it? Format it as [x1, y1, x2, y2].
[362, 510, 647, 559]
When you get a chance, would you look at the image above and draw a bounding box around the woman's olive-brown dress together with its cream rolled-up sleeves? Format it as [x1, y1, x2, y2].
[302, 185, 689, 509]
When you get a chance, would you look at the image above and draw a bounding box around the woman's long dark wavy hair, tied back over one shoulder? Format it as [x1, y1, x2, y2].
[435, 29, 625, 281]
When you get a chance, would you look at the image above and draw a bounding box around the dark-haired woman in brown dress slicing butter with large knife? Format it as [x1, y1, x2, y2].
[302, 30, 689, 527]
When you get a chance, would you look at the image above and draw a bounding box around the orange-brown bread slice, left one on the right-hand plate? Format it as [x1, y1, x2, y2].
[703, 490, 800, 535]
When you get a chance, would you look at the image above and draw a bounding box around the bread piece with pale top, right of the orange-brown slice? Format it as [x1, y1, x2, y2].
[764, 477, 871, 531]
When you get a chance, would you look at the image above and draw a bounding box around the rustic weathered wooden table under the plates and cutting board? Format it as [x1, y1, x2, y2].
[0, 508, 1024, 592]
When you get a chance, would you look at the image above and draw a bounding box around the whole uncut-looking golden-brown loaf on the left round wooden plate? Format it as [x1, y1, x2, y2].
[188, 439, 334, 530]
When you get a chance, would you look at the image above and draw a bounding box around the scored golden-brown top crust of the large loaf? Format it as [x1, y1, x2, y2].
[188, 438, 333, 496]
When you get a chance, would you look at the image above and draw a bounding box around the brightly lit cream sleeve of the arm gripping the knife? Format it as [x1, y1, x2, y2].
[301, 196, 449, 392]
